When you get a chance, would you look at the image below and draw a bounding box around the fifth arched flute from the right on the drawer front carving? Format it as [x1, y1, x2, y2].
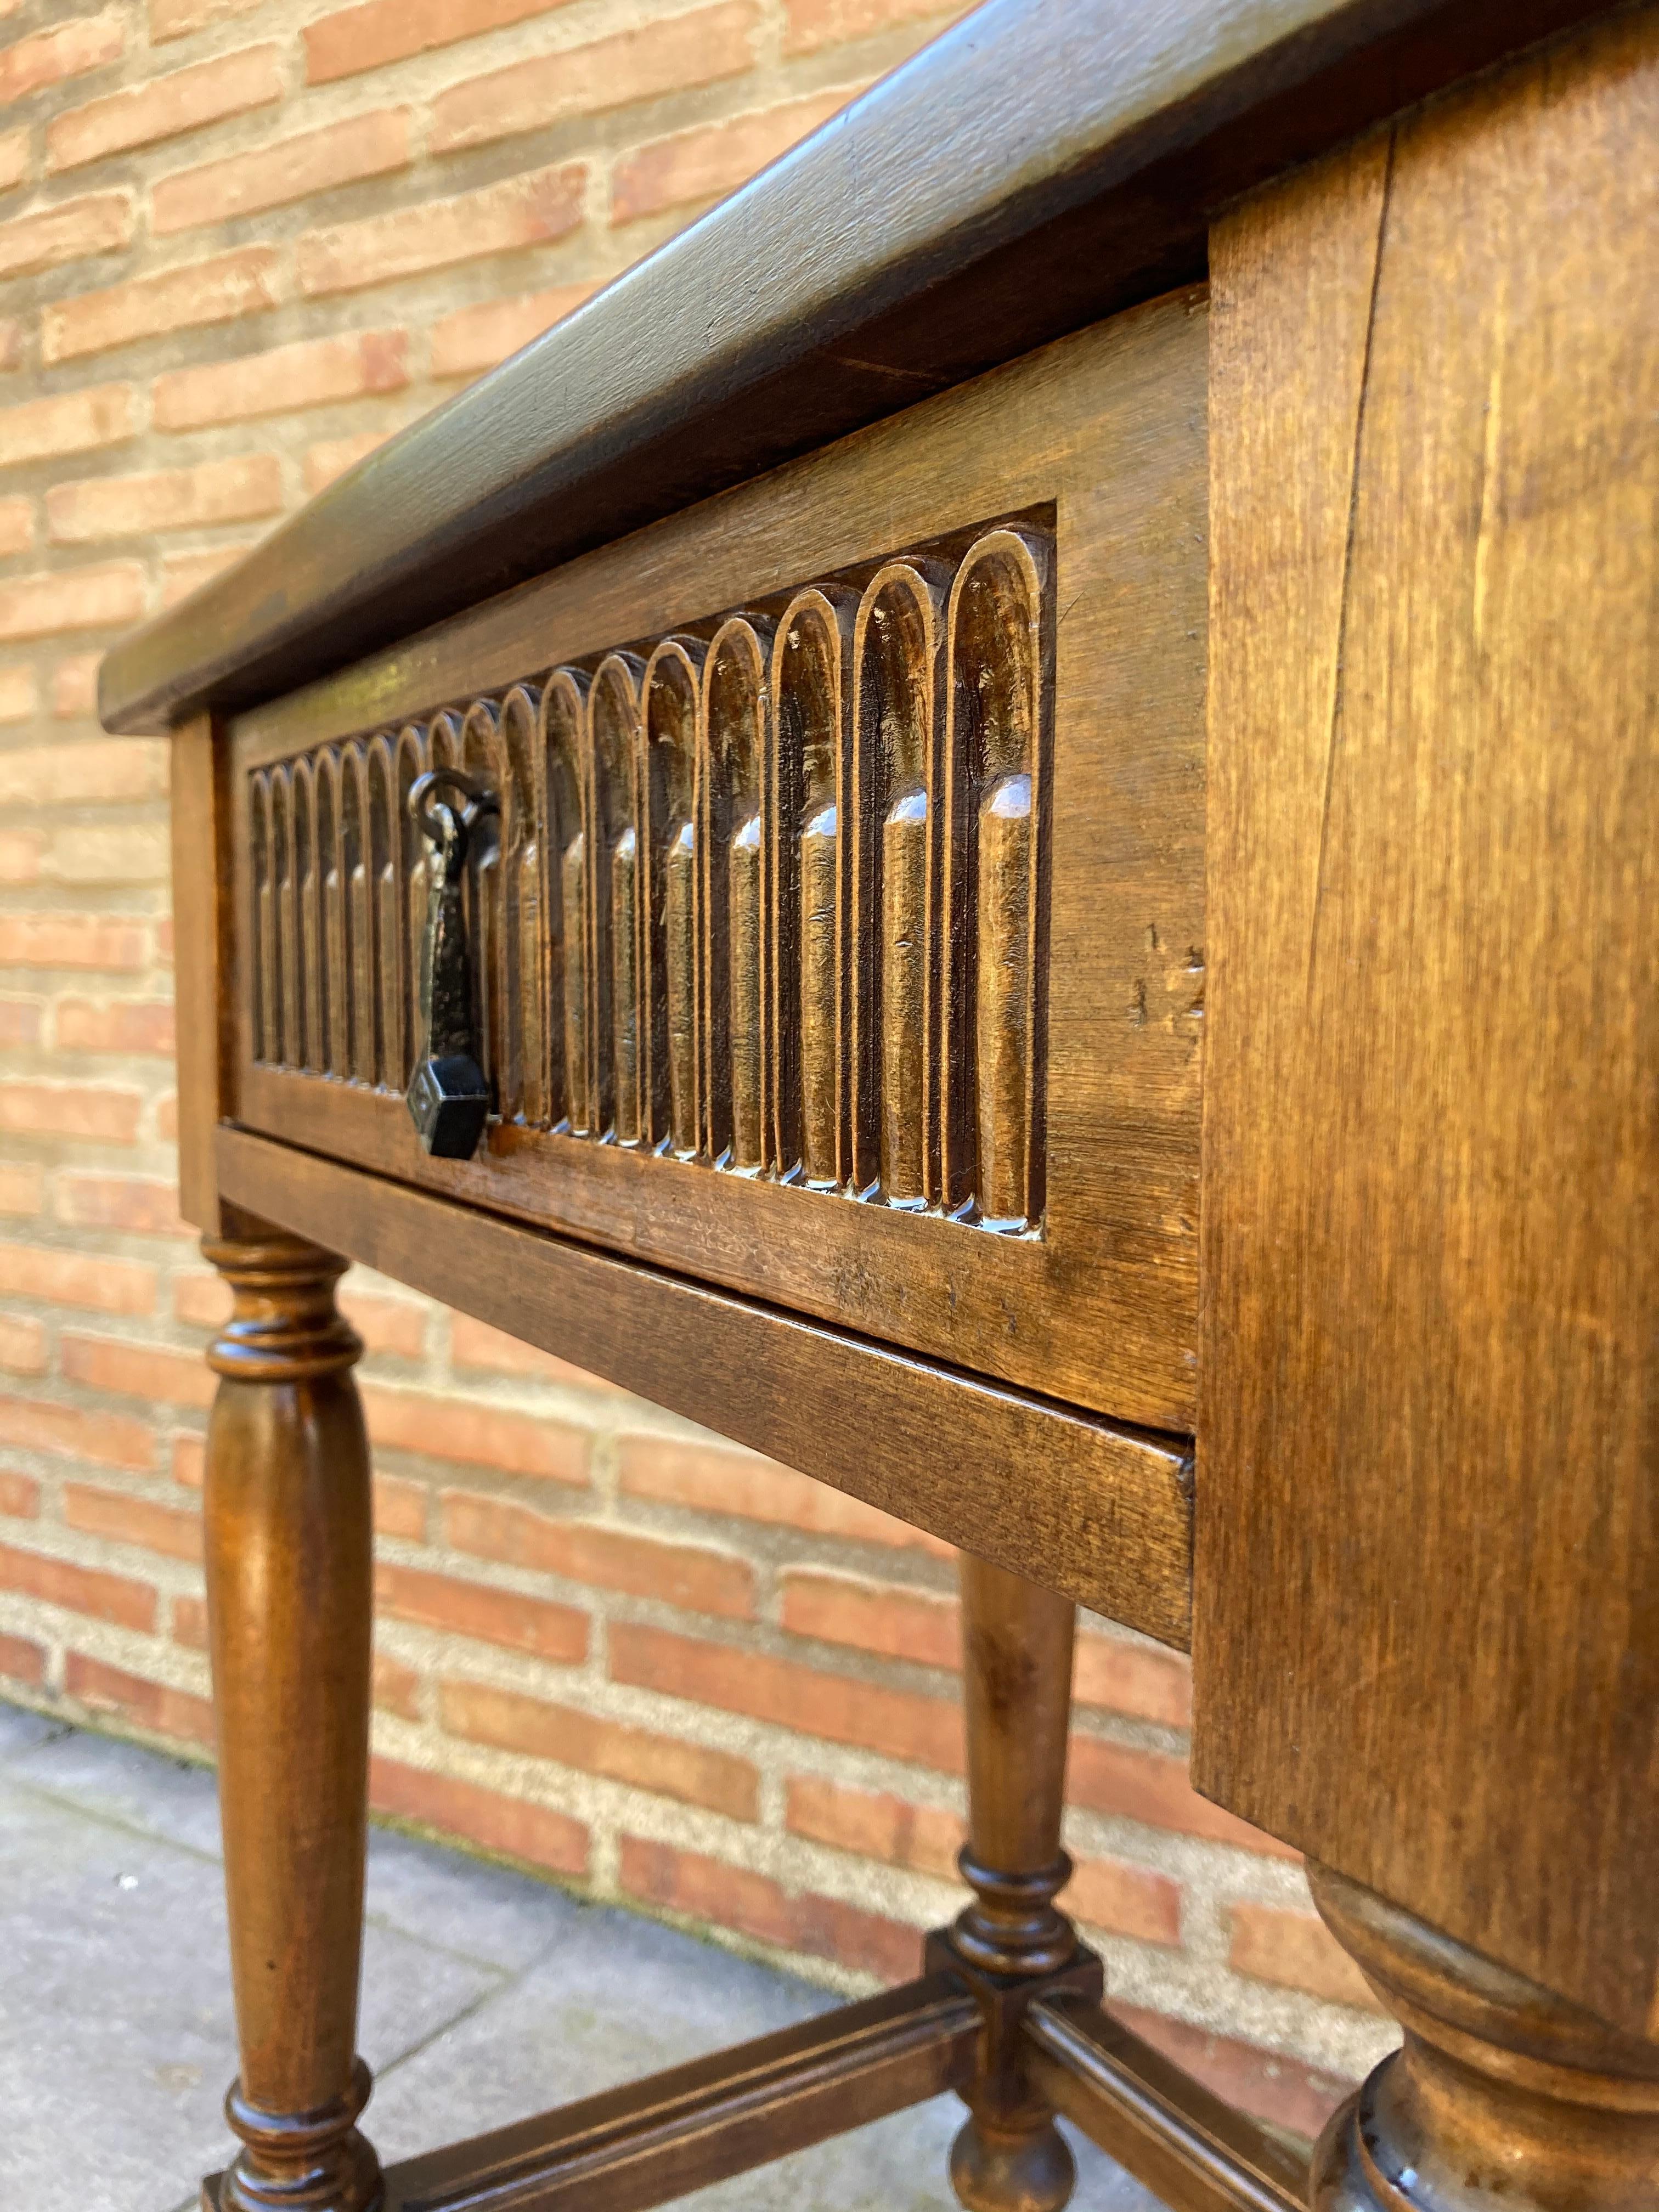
[641, 637, 703, 1159]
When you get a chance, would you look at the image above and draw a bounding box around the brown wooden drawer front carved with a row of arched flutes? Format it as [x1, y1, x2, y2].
[232, 296, 1203, 1427]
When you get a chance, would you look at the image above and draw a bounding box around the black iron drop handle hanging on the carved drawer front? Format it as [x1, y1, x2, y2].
[405, 768, 500, 1159]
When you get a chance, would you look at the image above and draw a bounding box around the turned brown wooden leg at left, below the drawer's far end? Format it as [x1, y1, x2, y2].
[204, 1223, 381, 2212]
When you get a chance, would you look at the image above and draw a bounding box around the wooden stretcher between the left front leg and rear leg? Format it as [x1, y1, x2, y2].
[263, 1973, 980, 2212]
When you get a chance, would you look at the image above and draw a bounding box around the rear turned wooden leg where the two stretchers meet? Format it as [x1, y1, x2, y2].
[951, 1553, 1097, 2212]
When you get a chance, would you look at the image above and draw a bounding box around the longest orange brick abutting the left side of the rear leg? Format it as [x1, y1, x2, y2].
[611, 1621, 962, 1772]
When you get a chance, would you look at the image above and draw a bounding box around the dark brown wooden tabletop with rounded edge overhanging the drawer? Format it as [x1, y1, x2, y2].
[99, 0, 1637, 730]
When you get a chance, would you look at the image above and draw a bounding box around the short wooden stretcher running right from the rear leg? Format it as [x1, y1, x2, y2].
[1020, 1989, 1307, 2212]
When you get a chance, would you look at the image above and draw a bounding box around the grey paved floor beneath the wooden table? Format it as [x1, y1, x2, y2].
[0, 1706, 1159, 2212]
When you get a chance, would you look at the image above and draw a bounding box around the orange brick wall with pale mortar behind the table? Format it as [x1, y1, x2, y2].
[0, 0, 1389, 2132]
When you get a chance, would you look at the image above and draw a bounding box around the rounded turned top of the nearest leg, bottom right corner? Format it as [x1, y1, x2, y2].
[1307, 1863, 1659, 2212]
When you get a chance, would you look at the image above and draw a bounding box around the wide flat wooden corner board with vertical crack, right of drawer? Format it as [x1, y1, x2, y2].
[1194, 9, 1659, 2033]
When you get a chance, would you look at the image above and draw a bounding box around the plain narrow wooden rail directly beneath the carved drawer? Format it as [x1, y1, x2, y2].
[217, 1128, 1192, 1648]
